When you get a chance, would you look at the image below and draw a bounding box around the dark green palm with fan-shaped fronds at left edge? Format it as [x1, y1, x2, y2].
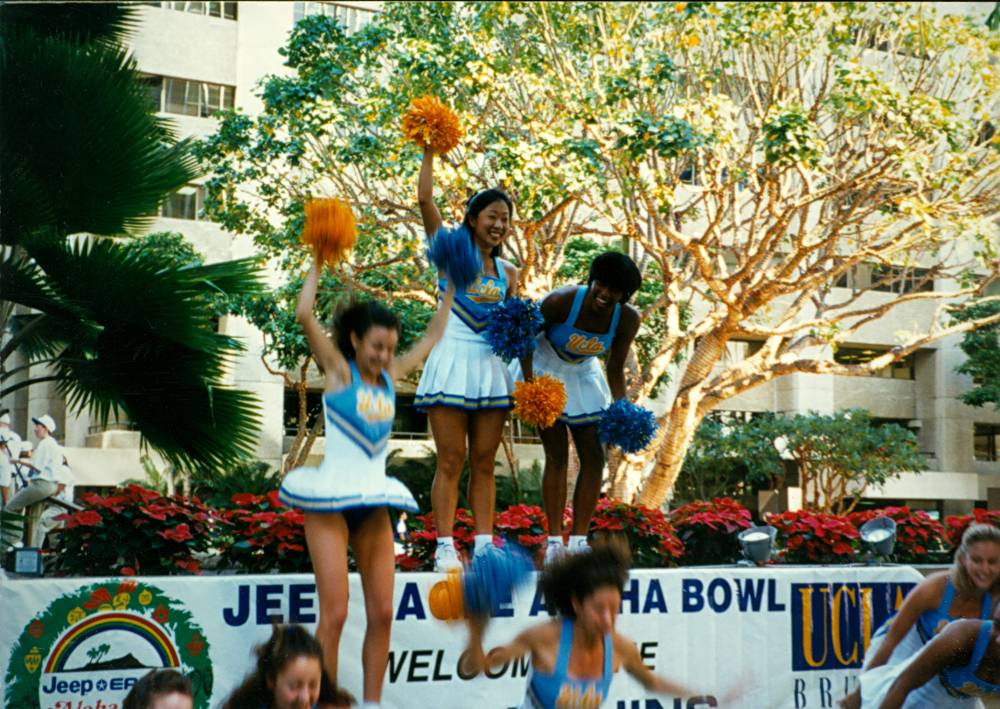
[0, 3, 259, 469]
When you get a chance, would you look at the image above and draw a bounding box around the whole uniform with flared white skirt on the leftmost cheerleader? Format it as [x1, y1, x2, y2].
[278, 360, 417, 513]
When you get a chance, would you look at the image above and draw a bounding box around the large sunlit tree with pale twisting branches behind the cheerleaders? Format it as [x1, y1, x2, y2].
[203, 2, 1000, 506]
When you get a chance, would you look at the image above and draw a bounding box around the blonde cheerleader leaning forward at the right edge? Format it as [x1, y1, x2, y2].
[841, 524, 1000, 709]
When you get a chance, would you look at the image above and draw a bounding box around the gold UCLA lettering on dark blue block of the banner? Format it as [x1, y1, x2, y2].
[791, 583, 915, 672]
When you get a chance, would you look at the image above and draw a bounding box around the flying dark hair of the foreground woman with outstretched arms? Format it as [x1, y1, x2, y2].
[538, 544, 629, 618]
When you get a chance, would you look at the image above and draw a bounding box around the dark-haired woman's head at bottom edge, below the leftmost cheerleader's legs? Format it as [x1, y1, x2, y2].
[222, 625, 353, 709]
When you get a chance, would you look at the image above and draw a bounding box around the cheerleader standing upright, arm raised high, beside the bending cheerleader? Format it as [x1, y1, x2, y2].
[415, 148, 518, 571]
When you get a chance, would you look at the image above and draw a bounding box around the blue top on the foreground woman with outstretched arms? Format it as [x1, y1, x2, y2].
[528, 618, 614, 709]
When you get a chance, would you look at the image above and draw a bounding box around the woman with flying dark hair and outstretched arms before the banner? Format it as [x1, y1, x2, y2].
[465, 545, 716, 709]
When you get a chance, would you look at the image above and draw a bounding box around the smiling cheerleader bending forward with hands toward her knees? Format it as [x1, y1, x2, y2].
[510, 251, 642, 561]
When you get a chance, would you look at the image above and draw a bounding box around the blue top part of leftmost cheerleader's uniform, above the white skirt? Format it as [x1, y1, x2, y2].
[323, 359, 396, 458]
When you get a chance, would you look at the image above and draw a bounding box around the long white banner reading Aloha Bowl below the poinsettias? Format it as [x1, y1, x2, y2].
[0, 566, 922, 709]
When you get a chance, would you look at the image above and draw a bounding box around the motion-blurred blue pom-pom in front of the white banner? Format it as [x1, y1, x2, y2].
[462, 542, 535, 615]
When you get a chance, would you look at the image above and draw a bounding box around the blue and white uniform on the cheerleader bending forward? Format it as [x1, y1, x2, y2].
[510, 286, 622, 426]
